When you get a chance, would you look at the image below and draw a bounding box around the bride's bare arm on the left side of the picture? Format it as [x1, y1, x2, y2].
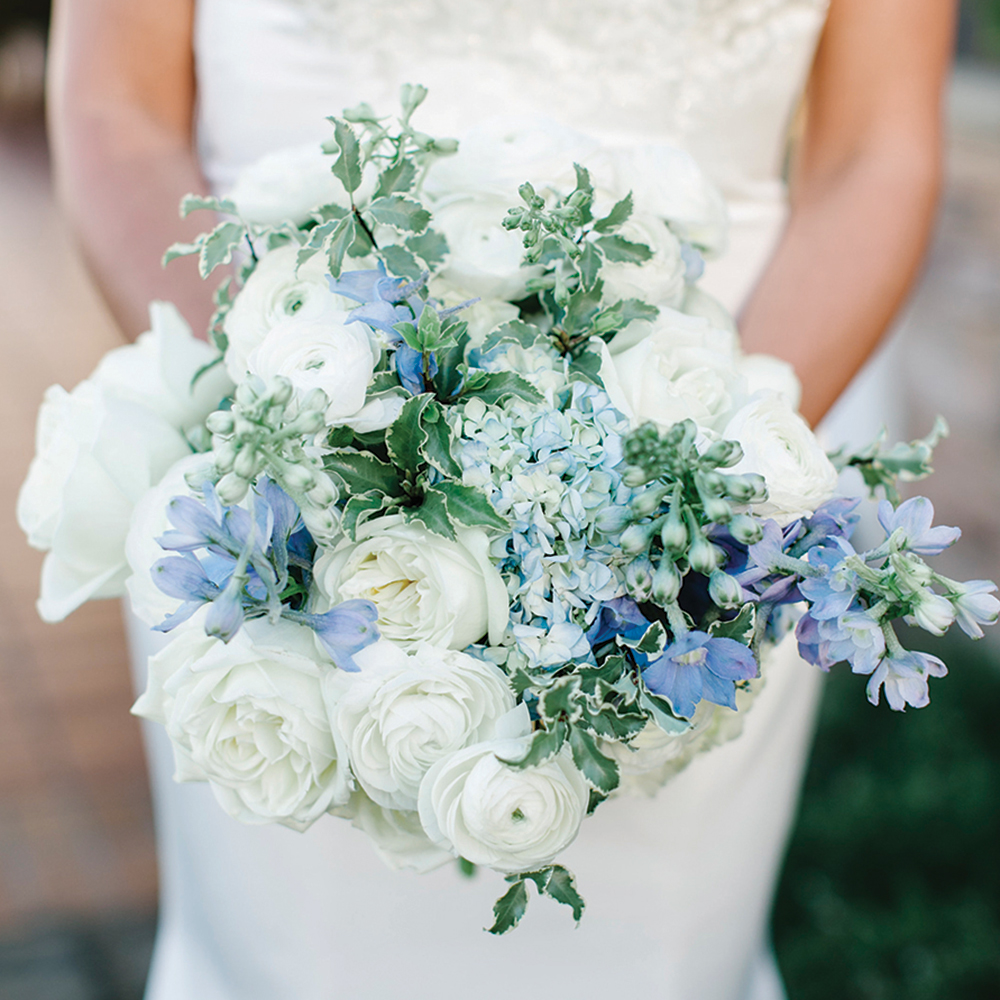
[49, 0, 211, 338]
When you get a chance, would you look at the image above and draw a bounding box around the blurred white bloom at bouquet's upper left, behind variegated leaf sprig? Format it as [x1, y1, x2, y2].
[226, 143, 371, 226]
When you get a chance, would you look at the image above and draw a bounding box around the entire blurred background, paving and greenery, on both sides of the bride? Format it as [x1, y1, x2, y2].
[0, 0, 1000, 1000]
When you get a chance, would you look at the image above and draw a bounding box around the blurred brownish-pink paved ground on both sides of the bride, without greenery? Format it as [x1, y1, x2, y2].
[0, 62, 1000, 1000]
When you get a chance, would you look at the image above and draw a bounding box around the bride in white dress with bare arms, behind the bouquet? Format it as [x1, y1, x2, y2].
[45, 0, 954, 1000]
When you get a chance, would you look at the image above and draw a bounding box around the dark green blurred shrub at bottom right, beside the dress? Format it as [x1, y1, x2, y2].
[774, 633, 1000, 1000]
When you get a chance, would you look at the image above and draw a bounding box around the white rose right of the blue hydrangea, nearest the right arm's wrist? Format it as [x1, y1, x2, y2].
[601, 309, 747, 430]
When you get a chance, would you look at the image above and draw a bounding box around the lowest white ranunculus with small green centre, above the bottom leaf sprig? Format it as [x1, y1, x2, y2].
[420, 705, 590, 872]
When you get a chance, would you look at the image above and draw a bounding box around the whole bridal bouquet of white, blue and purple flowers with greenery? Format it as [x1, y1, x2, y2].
[19, 87, 1000, 933]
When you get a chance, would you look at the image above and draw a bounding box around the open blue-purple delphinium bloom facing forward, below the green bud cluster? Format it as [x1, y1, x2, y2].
[642, 632, 757, 719]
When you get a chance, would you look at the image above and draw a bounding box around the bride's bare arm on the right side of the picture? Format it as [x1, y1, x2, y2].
[740, 0, 955, 423]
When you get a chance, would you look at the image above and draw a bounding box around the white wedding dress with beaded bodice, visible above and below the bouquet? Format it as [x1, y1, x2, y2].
[130, 0, 856, 1000]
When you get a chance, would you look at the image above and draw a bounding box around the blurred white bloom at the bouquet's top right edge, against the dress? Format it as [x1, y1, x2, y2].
[612, 145, 729, 253]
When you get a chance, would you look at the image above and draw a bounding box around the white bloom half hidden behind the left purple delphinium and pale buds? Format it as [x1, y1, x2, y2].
[125, 452, 214, 626]
